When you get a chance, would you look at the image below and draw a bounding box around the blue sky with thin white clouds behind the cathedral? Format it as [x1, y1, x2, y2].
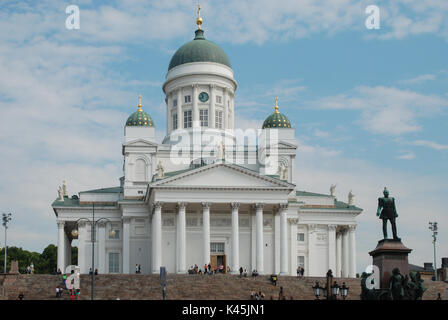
[0, 0, 448, 271]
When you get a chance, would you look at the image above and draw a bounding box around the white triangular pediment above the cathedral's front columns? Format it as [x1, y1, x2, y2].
[150, 163, 294, 190]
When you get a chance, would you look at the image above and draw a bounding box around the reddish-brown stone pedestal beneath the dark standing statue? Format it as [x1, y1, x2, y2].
[369, 239, 412, 289]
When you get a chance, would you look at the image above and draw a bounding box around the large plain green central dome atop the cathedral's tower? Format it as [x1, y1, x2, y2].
[168, 29, 232, 71]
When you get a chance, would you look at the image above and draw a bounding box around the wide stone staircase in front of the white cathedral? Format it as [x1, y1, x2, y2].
[0, 274, 445, 300]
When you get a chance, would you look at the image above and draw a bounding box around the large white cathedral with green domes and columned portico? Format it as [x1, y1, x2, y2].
[52, 7, 362, 277]
